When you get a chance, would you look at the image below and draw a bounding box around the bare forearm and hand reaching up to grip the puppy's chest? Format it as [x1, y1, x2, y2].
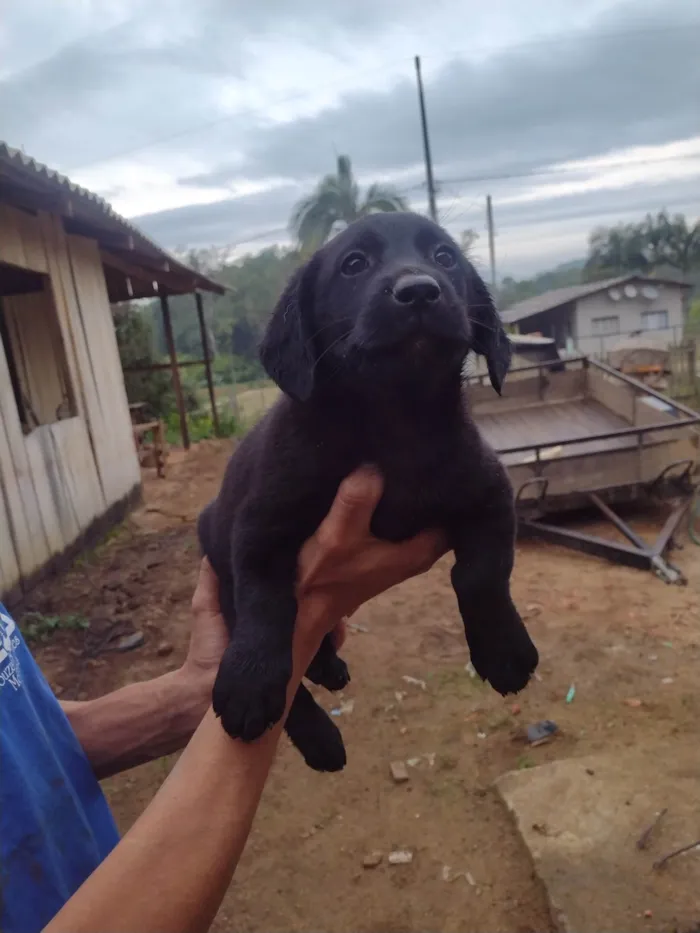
[46, 475, 444, 933]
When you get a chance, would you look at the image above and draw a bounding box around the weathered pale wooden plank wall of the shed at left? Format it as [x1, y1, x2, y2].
[0, 205, 140, 596]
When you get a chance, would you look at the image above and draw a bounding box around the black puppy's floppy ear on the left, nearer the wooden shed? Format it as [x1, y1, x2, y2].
[260, 257, 316, 402]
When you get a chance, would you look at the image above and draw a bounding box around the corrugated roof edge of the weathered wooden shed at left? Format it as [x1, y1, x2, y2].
[0, 140, 225, 297]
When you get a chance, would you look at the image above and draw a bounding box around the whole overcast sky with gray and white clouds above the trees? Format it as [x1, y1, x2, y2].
[0, 0, 700, 275]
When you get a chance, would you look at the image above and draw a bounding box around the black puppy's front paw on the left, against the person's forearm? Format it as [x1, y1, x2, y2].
[212, 642, 292, 742]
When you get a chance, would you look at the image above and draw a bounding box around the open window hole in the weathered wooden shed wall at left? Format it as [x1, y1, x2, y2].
[0, 263, 76, 434]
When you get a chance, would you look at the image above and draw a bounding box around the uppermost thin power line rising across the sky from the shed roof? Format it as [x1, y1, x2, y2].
[60, 20, 700, 174]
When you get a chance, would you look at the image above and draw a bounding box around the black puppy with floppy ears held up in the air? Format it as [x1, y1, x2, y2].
[199, 213, 538, 771]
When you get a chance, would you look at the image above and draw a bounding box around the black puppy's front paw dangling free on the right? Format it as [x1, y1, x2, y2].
[467, 611, 539, 696]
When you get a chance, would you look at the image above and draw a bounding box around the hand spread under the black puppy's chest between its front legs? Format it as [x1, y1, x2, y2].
[297, 467, 447, 656]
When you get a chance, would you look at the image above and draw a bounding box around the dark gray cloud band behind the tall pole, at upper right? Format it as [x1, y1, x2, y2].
[205, 2, 700, 184]
